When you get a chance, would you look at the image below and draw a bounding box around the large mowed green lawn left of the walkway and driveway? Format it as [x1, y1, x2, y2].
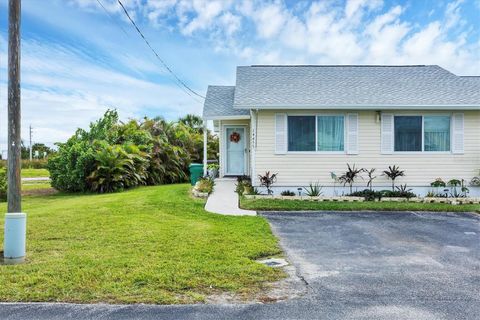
[0, 185, 283, 304]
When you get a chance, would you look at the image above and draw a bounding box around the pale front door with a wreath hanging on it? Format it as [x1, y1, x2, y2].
[225, 127, 247, 176]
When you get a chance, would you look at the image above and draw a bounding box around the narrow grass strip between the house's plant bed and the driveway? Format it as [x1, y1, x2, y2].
[240, 198, 480, 212]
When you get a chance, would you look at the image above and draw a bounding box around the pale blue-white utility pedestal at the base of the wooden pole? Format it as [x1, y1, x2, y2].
[3, 212, 27, 264]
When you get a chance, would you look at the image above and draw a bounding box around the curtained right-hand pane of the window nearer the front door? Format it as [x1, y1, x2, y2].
[317, 116, 345, 151]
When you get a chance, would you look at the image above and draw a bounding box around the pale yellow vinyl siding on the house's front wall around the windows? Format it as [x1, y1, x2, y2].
[255, 110, 480, 187]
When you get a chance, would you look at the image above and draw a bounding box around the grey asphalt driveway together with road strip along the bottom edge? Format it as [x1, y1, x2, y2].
[0, 212, 480, 320]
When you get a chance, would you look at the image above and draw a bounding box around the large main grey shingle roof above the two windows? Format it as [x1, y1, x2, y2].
[232, 65, 480, 109]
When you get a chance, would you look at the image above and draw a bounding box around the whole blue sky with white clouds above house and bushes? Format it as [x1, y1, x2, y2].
[0, 0, 480, 150]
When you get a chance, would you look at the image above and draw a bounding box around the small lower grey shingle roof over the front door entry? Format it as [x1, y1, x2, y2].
[203, 86, 250, 119]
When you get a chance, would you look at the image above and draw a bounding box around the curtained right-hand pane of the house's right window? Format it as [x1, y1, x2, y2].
[423, 116, 450, 151]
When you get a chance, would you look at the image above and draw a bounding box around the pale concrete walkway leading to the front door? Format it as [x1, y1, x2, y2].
[205, 178, 257, 216]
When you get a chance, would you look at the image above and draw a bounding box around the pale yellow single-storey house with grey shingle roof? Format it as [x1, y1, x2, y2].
[203, 65, 480, 195]
